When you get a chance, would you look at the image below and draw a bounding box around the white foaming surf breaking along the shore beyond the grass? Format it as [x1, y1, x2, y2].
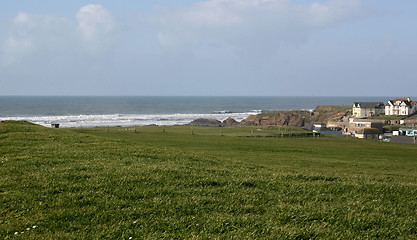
[0, 111, 259, 128]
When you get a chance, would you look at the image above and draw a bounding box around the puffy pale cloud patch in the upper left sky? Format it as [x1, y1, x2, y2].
[0, 4, 120, 66]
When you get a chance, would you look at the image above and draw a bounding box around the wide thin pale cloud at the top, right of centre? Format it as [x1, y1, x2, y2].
[151, 0, 372, 50]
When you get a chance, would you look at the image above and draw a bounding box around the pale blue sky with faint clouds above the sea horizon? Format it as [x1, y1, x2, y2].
[0, 0, 417, 97]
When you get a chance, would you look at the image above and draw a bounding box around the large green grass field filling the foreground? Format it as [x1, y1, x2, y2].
[0, 121, 417, 239]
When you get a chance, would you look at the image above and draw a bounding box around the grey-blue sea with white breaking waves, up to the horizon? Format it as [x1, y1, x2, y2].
[0, 96, 390, 128]
